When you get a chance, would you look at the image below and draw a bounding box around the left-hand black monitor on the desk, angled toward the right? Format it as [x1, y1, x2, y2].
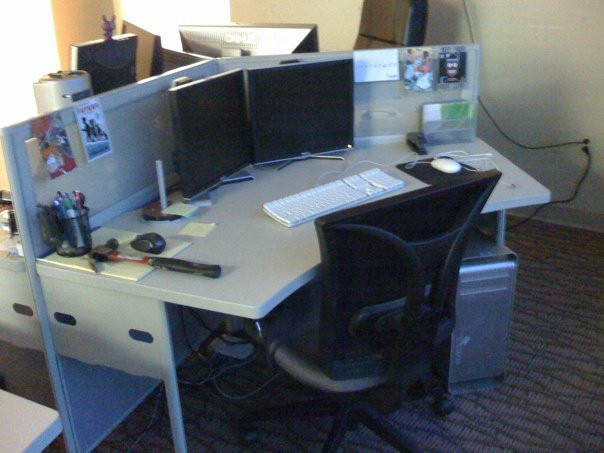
[169, 70, 252, 199]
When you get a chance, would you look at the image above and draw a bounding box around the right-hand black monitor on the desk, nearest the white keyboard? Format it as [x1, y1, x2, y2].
[248, 59, 354, 163]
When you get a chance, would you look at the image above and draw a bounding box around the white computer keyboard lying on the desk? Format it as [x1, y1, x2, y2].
[263, 168, 404, 227]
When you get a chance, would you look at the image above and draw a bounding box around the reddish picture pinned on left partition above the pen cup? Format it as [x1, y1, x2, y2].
[31, 113, 77, 179]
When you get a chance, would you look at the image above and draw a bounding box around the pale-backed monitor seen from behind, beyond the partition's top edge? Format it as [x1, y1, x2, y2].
[178, 23, 319, 57]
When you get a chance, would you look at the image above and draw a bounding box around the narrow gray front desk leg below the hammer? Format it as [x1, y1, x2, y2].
[157, 301, 187, 453]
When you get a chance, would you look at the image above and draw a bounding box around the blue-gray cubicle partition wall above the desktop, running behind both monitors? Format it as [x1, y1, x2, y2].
[1, 45, 480, 257]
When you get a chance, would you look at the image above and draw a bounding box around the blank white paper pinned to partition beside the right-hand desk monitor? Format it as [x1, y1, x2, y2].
[352, 49, 401, 82]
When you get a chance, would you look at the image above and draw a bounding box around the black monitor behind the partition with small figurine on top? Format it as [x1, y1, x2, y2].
[70, 33, 137, 94]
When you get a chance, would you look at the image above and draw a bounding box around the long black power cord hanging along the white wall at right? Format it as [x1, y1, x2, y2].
[462, 0, 591, 226]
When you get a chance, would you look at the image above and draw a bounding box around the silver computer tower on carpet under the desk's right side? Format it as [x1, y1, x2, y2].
[448, 241, 517, 393]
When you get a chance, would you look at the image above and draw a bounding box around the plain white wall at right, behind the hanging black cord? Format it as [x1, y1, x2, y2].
[427, 0, 604, 230]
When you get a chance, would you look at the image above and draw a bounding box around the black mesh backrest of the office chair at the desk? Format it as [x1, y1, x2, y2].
[315, 170, 501, 378]
